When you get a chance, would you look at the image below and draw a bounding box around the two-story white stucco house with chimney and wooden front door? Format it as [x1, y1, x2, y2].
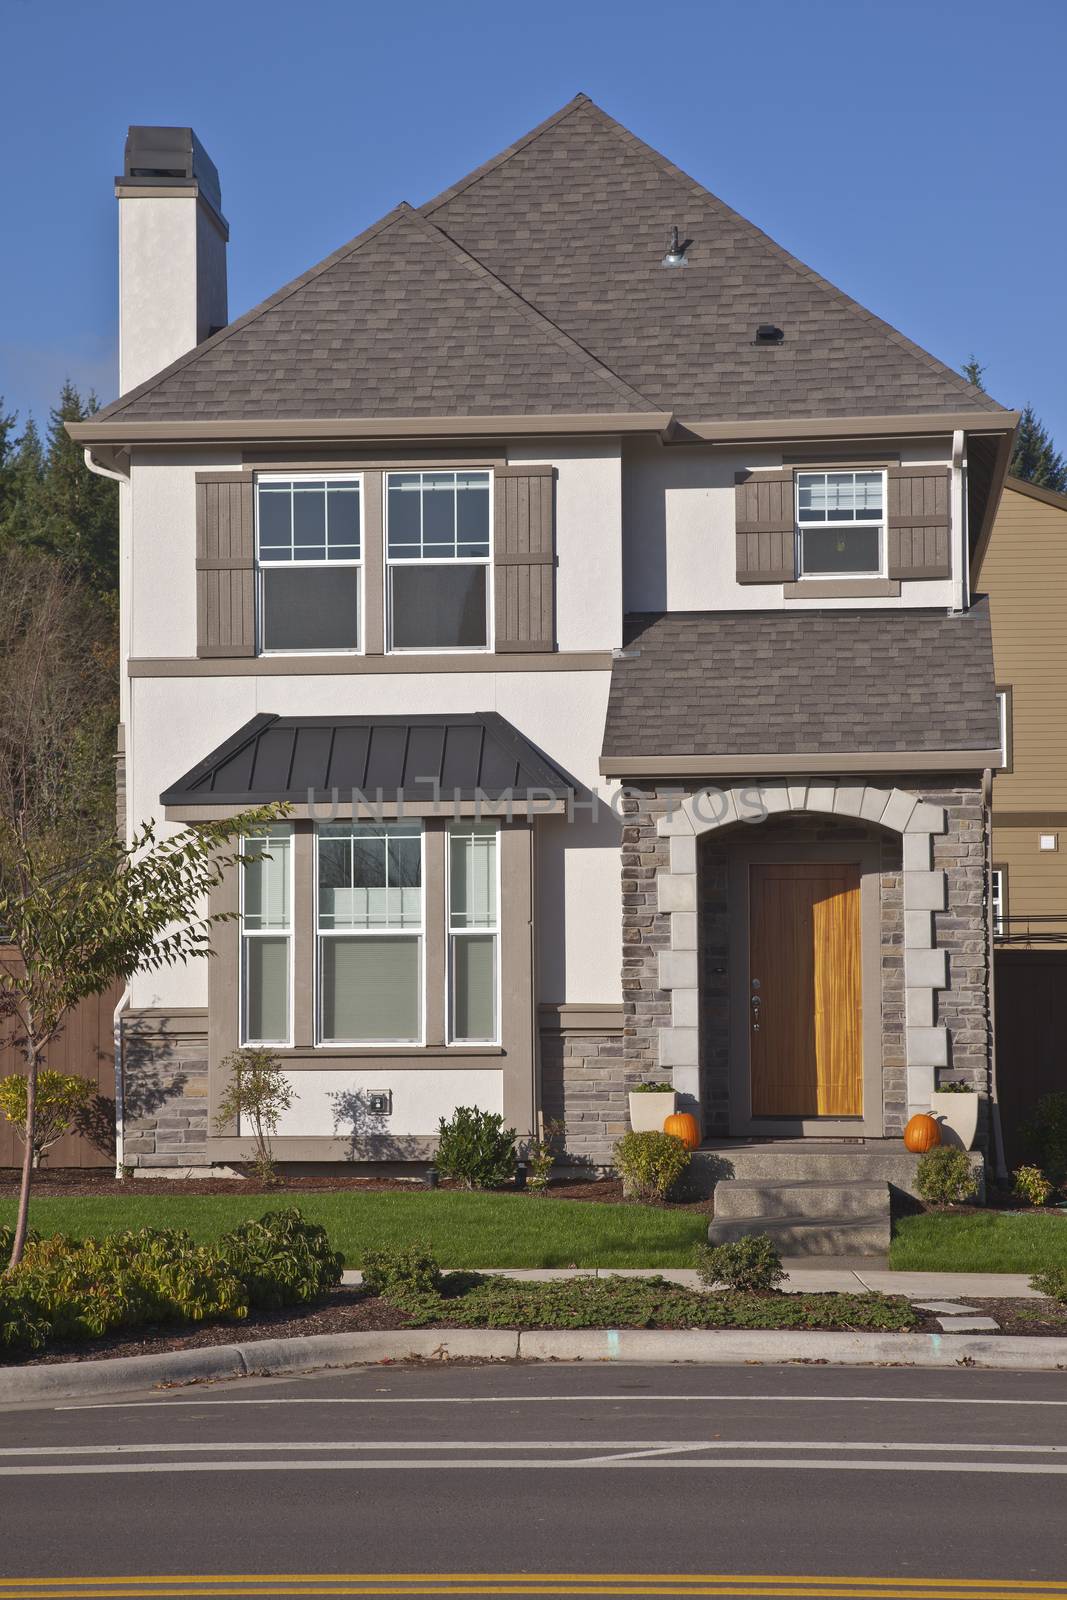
[70, 96, 1016, 1222]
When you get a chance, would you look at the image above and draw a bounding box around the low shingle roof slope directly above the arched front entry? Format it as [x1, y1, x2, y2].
[603, 600, 1000, 758]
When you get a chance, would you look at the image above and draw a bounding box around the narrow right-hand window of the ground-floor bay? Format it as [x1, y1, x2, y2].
[448, 822, 499, 1045]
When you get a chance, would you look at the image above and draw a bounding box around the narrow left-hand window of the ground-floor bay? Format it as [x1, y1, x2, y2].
[240, 826, 293, 1045]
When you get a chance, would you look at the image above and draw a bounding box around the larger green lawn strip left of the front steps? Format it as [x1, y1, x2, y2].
[0, 1190, 707, 1267]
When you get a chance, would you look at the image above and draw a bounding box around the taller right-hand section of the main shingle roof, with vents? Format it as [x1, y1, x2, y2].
[422, 94, 1001, 419]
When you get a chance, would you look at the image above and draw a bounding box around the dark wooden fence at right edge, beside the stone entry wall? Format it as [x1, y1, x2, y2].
[993, 949, 1067, 1166]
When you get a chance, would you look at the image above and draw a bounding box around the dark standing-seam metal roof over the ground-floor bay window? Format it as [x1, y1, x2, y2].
[160, 710, 573, 806]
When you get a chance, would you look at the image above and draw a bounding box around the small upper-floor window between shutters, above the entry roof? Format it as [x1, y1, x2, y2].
[797, 472, 885, 578]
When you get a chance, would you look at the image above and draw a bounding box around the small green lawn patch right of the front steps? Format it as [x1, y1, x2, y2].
[889, 1210, 1067, 1272]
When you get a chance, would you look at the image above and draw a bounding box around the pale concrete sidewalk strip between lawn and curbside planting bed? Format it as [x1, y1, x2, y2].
[337, 1256, 1041, 1301]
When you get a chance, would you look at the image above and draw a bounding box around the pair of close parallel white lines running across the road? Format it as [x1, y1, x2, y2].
[0, 1438, 1067, 1459]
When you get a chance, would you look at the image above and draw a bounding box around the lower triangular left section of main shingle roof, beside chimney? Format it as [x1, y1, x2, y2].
[93, 205, 654, 424]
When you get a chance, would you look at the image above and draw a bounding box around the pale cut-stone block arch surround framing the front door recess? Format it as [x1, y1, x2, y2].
[656, 779, 949, 1115]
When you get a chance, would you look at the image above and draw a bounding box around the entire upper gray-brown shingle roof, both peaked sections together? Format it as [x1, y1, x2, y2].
[93, 94, 995, 424]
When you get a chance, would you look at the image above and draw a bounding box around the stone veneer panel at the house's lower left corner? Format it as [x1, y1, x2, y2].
[122, 1011, 208, 1168]
